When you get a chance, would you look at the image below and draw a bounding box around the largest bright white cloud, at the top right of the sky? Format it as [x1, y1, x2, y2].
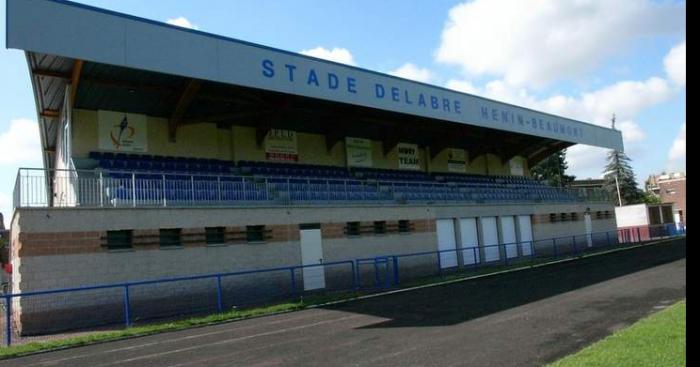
[435, 0, 685, 86]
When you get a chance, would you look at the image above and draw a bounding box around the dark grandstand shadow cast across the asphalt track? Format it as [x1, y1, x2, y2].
[324, 238, 686, 328]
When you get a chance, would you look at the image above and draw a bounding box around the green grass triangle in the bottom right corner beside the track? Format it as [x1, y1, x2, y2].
[550, 301, 686, 367]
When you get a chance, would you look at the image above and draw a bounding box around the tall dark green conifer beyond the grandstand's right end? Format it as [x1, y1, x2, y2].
[604, 150, 644, 205]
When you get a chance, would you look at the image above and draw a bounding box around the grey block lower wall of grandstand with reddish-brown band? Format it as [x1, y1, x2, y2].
[11, 204, 615, 335]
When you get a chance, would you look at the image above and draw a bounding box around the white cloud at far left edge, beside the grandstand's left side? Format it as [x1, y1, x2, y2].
[0, 118, 42, 166]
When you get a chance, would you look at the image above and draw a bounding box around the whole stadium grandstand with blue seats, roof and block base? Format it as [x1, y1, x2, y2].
[7, 0, 623, 332]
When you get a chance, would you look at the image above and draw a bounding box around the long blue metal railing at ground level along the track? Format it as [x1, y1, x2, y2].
[1, 225, 685, 346]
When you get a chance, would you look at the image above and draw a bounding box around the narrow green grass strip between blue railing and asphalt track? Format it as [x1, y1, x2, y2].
[0, 237, 680, 359]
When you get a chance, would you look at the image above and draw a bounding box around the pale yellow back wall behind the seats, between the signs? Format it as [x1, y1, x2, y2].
[73, 109, 529, 175]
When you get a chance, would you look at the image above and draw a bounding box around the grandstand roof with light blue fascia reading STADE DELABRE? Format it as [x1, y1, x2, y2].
[6, 0, 623, 172]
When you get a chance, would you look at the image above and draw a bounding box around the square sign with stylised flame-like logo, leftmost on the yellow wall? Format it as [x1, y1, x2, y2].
[97, 110, 148, 152]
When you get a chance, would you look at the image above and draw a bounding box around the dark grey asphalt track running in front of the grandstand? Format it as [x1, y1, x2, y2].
[0, 239, 686, 367]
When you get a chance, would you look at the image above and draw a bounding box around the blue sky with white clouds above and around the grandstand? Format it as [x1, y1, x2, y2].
[0, 0, 686, 227]
